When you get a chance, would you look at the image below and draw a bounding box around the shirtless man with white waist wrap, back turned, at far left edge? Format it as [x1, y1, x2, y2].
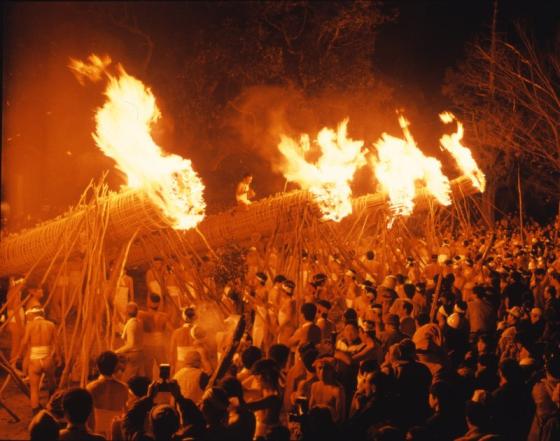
[12, 307, 56, 413]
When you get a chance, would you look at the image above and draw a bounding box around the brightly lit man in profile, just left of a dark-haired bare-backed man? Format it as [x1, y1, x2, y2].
[115, 302, 144, 381]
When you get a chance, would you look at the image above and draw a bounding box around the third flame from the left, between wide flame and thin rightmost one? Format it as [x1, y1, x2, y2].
[370, 116, 451, 216]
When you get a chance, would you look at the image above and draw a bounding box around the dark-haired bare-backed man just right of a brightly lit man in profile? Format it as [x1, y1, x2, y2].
[138, 293, 172, 378]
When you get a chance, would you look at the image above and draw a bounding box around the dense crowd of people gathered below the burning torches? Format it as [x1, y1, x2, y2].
[3, 213, 560, 441]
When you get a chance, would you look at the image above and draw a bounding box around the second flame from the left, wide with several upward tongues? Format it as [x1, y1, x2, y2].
[278, 119, 366, 222]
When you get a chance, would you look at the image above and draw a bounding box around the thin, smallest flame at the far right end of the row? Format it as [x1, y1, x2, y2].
[439, 112, 486, 193]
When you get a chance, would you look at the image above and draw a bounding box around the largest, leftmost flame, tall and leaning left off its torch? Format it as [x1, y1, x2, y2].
[70, 55, 206, 229]
